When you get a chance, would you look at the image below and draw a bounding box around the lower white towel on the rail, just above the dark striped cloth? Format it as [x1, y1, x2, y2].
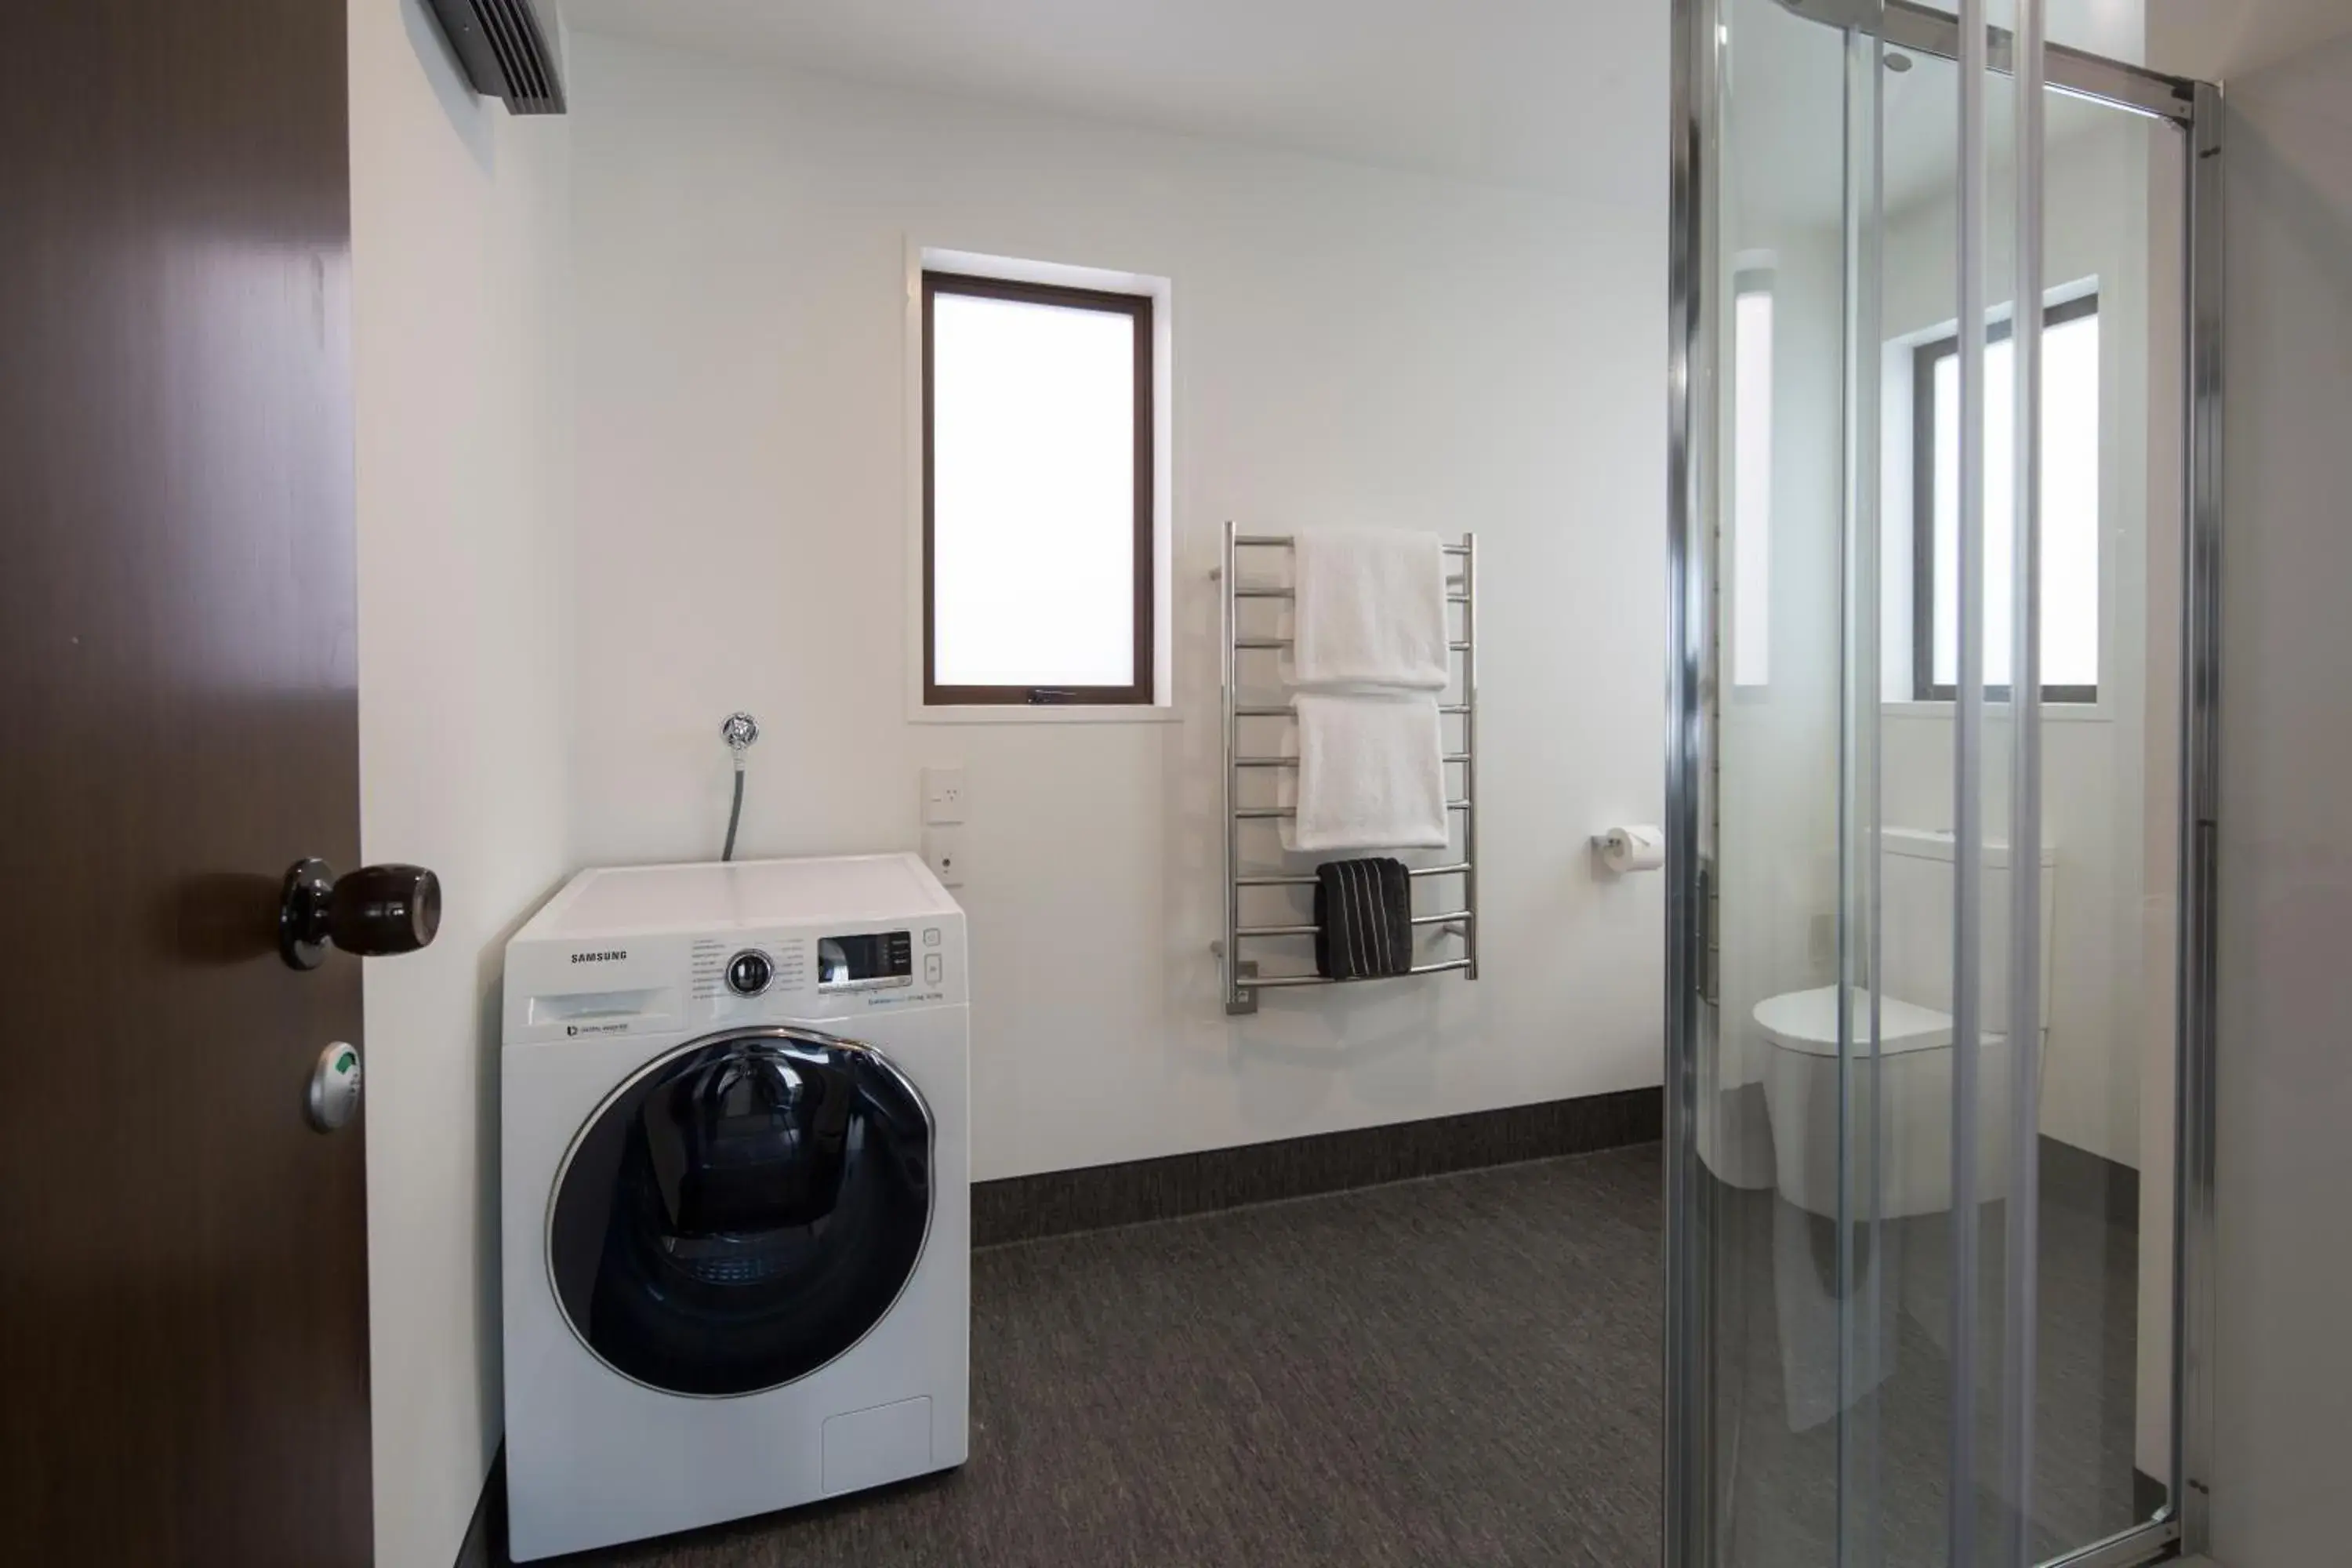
[1282, 691, 1454, 851]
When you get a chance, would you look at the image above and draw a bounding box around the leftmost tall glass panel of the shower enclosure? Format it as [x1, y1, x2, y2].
[1670, 0, 1872, 1563]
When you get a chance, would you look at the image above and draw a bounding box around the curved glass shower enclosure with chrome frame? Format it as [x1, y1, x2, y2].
[1665, 0, 2220, 1568]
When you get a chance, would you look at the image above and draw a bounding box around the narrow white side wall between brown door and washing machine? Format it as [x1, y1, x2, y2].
[350, 0, 569, 1568]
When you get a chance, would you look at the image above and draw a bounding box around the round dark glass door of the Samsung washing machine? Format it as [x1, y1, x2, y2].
[548, 1029, 931, 1396]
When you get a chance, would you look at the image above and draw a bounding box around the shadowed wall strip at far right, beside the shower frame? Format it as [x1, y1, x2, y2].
[2213, 33, 2352, 1568]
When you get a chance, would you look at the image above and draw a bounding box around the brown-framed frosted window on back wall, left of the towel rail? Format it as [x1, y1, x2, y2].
[922, 270, 1157, 708]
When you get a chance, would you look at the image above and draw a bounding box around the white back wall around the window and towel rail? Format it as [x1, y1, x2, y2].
[557, 33, 1665, 1178]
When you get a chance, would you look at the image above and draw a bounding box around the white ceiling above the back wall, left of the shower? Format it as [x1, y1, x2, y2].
[562, 0, 1670, 207]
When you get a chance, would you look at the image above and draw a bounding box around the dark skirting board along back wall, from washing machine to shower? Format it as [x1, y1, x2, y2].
[971, 1088, 1665, 1246]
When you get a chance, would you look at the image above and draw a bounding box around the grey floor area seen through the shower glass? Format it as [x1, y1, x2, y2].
[1712, 1187, 2161, 1568]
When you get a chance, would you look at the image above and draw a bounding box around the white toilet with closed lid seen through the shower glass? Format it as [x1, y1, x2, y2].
[1752, 827, 2056, 1220]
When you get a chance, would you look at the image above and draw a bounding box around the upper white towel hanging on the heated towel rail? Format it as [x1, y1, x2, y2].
[1291, 529, 1451, 691]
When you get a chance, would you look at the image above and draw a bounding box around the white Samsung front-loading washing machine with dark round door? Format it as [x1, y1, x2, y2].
[499, 855, 971, 1561]
